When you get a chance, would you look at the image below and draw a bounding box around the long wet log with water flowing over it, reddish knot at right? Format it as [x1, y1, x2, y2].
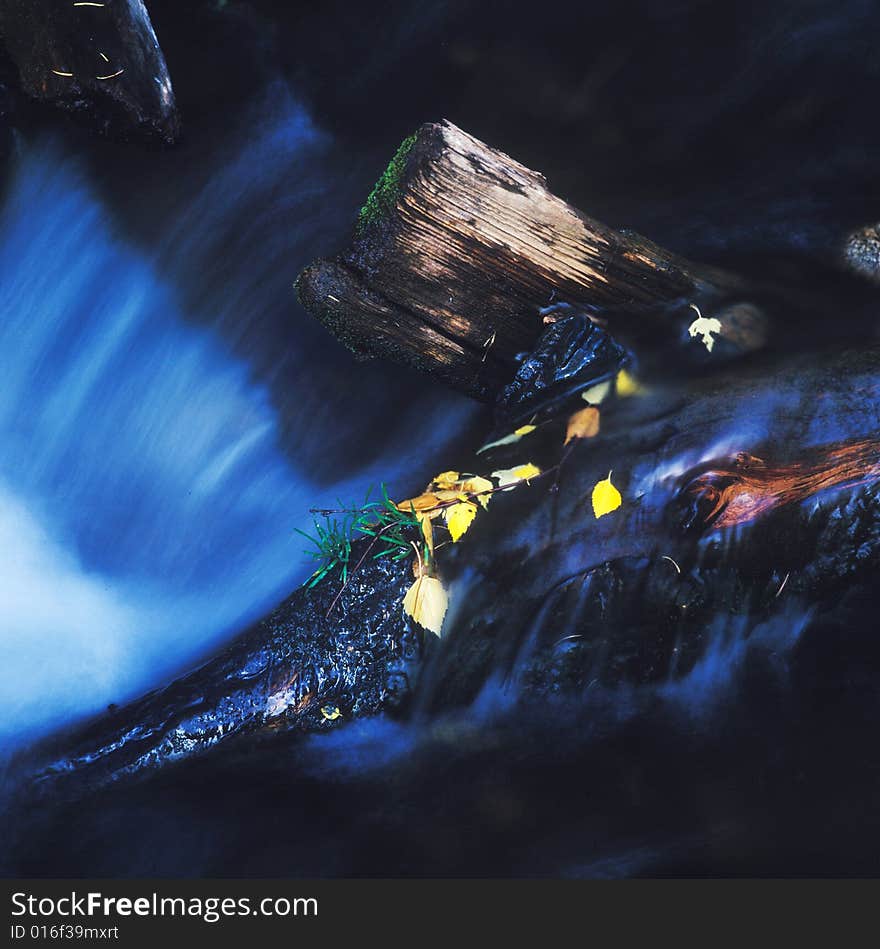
[12, 350, 880, 797]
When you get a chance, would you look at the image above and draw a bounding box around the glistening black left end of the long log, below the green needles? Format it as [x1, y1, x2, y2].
[17, 561, 421, 799]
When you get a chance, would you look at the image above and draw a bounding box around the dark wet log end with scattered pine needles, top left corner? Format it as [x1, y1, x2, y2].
[0, 0, 179, 142]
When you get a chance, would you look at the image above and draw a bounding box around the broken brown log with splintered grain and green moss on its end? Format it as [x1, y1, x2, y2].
[297, 122, 766, 400]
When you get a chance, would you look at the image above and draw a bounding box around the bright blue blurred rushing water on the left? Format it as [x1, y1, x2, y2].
[0, 95, 474, 751]
